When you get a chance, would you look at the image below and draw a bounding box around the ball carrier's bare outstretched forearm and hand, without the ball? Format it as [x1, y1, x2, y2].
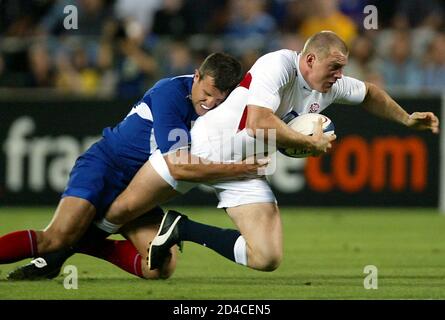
[362, 82, 439, 133]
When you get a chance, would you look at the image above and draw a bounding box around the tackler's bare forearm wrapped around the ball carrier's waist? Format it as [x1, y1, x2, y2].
[164, 149, 269, 182]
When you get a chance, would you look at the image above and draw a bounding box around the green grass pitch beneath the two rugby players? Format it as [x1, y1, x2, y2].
[0, 208, 445, 300]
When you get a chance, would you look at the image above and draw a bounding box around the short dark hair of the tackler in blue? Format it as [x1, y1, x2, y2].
[198, 52, 243, 92]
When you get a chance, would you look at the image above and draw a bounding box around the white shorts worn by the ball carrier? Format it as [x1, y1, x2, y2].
[150, 150, 276, 208]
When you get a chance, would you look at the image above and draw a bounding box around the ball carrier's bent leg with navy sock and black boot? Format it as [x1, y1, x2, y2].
[150, 202, 283, 271]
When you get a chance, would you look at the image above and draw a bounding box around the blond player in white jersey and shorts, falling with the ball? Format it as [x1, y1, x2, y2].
[86, 31, 439, 271]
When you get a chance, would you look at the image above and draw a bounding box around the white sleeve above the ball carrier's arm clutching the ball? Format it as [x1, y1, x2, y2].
[247, 50, 296, 112]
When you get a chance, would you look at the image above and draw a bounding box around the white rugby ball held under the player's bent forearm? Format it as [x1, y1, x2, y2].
[278, 113, 335, 158]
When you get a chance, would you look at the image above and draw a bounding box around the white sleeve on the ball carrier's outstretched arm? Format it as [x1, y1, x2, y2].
[332, 76, 366, 104]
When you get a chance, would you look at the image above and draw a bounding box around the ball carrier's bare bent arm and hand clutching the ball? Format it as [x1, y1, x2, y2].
[246, 105, 336, 155]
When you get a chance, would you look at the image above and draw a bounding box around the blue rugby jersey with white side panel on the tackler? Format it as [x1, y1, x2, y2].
[103, 75, 198, 169]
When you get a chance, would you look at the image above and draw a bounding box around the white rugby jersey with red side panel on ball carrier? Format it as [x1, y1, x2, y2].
[191, 50, 366, 161]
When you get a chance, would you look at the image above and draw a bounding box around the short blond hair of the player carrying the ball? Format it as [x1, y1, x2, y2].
[302, 31, 349, 59]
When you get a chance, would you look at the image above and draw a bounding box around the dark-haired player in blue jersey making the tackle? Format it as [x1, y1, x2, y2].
[0, 53, 261, 279]
